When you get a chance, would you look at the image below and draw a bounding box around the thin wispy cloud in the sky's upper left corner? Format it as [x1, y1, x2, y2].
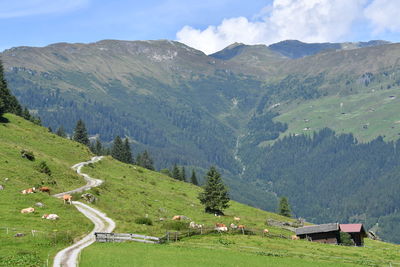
[0, 0, 90, 19]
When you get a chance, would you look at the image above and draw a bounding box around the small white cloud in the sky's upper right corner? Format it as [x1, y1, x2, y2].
[364, 0, 400, 33]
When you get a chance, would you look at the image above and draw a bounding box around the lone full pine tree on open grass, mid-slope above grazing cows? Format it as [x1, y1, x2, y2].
[199, 166, 230, 214]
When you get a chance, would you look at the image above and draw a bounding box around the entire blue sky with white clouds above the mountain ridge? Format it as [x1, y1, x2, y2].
[0, 0, 400, 54]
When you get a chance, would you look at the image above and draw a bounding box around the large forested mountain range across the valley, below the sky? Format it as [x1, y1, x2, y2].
[1, 40, 400, 242]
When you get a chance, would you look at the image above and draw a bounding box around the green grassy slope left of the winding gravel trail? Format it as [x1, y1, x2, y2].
[0, 114, 92, 266]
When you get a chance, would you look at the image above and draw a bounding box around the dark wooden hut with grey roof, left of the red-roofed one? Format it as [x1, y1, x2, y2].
[296, 223, 340, 244]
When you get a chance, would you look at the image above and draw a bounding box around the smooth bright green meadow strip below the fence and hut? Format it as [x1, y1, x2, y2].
[80, 238, 400, 266]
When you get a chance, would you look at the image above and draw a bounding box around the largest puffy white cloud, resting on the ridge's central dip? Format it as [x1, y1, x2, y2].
[177, 0, 367, 54]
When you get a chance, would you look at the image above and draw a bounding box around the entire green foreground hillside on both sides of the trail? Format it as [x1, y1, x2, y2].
[0, 113, 400, 266]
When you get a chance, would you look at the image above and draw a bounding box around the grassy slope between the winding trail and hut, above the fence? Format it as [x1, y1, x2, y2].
[79, 157, 296, 236]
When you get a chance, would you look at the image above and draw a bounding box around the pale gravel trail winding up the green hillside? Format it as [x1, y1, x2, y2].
[53, 157, 115, 267]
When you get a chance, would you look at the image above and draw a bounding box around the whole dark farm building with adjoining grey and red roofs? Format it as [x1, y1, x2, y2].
[296, 223, 367, 246]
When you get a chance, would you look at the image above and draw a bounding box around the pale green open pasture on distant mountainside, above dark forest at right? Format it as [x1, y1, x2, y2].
[275, 90, 400, 142]
